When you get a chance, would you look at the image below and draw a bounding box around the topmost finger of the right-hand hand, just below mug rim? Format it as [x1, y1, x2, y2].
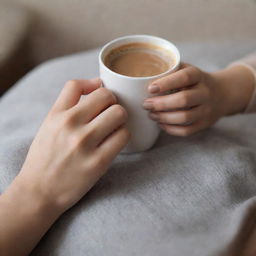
[148, 66, 201, 93]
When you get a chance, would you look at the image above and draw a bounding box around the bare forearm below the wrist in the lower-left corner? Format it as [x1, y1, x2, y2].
[0, 174, 59, 256]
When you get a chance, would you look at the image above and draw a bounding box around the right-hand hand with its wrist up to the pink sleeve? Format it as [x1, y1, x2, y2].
[143, 64, 254, 136]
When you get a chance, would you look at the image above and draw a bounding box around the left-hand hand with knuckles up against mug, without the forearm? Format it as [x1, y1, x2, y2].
[16, 79, 129, 213]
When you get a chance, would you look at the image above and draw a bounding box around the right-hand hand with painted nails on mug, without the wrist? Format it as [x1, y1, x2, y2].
[143, 64, 225, 136]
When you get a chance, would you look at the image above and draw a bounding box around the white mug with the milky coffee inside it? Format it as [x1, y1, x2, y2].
[99, 35, 180, 153]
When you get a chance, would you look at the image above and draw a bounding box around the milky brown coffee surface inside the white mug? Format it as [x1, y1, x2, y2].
[104, 43, 176, 77]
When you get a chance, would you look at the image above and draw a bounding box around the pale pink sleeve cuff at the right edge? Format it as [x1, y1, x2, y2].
[231, 52, 256, 113]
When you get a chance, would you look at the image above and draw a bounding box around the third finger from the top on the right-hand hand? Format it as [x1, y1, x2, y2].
[149, 106, 203, 125]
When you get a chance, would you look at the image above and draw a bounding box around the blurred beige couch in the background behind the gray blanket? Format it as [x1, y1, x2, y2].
[0, 0, 256, 94]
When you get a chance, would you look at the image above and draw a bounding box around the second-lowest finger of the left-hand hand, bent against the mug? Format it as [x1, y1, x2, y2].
[86, 104, 128, 146]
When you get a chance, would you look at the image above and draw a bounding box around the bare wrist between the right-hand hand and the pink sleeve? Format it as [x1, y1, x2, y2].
[213, 65, 255, 116]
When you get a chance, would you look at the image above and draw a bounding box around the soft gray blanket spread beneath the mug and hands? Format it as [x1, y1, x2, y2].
[0, 42, 256, 256]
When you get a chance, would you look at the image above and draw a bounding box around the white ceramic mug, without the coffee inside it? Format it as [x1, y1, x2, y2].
[99, 35, 180, 153]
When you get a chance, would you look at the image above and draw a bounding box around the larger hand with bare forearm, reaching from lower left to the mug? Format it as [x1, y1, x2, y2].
[0, 79, 129, 255]
